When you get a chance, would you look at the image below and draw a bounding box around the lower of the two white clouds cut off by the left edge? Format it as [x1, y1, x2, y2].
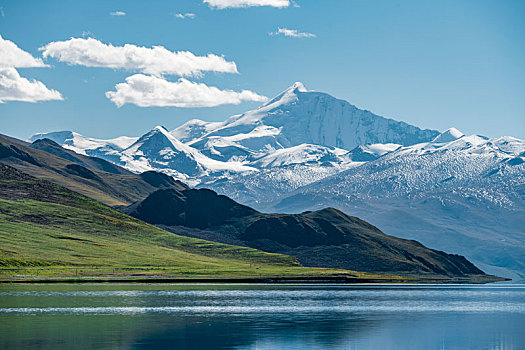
[0, 68, 63, 103]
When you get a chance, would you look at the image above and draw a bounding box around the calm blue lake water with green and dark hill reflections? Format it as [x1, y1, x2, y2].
[0, 284, 525, 350]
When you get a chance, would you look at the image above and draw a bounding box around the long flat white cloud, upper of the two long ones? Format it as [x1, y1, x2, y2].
[40, 38, 238, 76]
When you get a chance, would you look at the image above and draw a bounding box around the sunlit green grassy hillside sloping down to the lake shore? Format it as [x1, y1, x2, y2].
[0, 164, 392, 278]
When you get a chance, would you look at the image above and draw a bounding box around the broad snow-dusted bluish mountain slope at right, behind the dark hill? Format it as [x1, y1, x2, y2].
[260, 131, 525, 279]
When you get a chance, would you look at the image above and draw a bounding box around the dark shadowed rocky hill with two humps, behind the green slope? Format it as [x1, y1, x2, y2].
[124, 189, 496, 279]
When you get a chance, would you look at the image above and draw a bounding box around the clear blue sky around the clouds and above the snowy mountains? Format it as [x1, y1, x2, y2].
[0, 0, 525, 138]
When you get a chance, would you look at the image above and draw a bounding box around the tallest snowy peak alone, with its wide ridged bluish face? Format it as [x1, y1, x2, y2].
[186, 83, 439, 160]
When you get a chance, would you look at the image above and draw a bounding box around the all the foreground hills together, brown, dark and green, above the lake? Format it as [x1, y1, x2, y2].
[0, 134, 498, 282]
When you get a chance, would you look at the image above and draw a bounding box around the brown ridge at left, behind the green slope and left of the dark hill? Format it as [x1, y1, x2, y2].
[0, 135, 186, 206]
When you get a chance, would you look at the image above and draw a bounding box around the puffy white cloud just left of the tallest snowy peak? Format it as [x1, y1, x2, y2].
[106, 74, 267, 108]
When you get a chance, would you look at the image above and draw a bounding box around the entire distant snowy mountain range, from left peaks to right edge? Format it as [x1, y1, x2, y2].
[31, 83, 525, 279]
